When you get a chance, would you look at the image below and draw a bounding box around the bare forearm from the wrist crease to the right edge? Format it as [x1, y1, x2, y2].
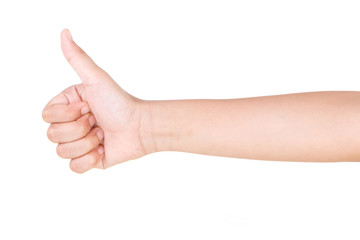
[141, 91, 360, 162]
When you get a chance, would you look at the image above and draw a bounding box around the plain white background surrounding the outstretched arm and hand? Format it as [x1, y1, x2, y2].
[0, 0, 360, 240]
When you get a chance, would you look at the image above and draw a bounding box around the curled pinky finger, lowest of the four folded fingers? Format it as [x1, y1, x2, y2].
[70, 145, 104, 173]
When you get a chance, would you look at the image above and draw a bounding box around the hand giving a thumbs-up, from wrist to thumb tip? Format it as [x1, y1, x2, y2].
[43, 29, 152, 173]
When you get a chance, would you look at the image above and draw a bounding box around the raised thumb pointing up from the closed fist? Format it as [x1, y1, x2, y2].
[61, 29, 109, 84]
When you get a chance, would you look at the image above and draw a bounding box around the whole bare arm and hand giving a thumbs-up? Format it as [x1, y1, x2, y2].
[42, 29, 360, 173]
